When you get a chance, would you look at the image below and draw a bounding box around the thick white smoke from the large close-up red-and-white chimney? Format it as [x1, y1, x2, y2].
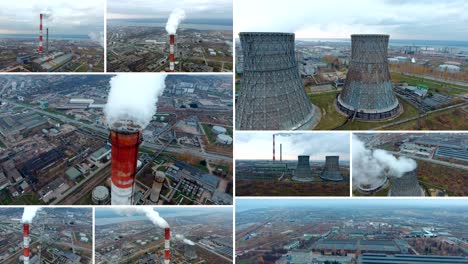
[104, 73, 166, 129]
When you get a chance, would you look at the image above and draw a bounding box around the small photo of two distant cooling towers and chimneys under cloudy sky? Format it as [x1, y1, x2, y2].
[235, 132, 350, 196]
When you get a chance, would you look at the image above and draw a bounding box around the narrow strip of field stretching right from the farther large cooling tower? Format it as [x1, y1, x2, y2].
[392, 72, 468, 95]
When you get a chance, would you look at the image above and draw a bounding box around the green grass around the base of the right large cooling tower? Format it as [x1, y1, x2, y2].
[310, 92, 418, 130]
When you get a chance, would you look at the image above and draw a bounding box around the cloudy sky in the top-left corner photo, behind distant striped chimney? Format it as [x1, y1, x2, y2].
[0, 0, 105, 35]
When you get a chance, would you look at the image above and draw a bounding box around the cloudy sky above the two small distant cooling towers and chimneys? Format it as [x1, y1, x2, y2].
[234, 132, 349, 160]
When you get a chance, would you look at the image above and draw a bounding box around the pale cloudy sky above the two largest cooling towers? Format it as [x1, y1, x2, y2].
[234, 0, 468, 41]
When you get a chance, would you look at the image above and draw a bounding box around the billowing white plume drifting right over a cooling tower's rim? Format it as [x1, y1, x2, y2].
[353, 135, 417, 188]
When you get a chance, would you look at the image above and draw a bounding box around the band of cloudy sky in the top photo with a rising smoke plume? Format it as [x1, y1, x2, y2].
[107, 0, 233, 19]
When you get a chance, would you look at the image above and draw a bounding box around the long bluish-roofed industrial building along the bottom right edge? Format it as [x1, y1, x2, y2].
[358, 253, 468, 264]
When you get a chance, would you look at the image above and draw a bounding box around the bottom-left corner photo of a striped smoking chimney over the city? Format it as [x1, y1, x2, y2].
[0, 207, 93, 264]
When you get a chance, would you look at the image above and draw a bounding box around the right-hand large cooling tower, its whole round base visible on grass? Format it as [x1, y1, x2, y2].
[337, 35, 399, 120]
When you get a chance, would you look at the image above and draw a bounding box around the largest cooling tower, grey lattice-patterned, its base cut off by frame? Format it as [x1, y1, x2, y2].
[236, 32, 318, 130]
